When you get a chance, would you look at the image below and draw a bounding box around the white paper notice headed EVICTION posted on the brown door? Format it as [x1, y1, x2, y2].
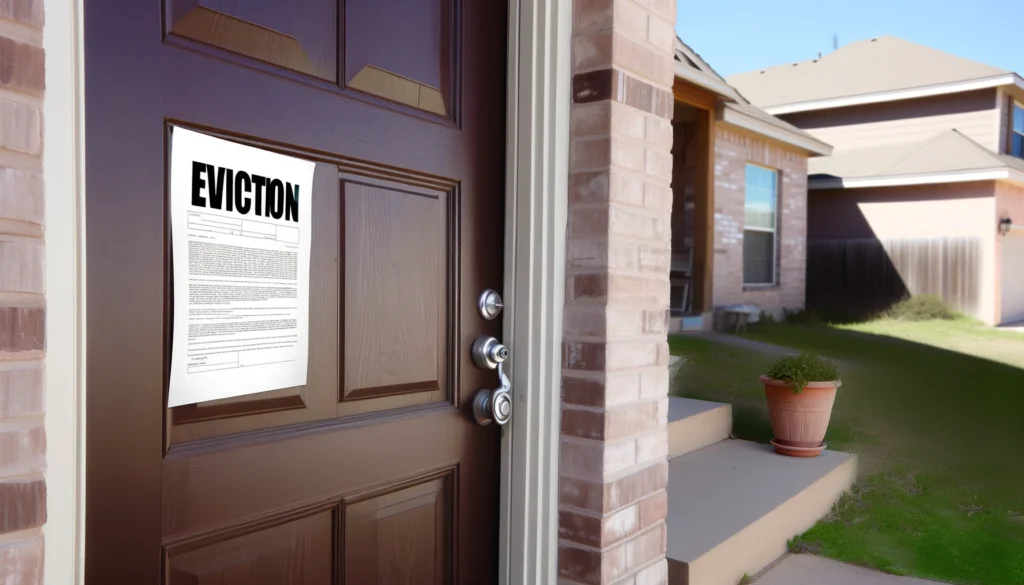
[168, 127, 314, 407]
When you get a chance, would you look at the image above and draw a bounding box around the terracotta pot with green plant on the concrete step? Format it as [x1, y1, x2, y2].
[761, 353, 842, 457]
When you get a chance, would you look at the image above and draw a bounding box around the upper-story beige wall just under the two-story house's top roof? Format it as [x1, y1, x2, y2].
[782, 89, 1001, 151]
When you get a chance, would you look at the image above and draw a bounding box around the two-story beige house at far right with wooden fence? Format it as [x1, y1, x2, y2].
[728, 37, 1024, 324]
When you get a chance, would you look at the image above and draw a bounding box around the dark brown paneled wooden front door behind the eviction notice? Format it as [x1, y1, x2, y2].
[86, 0, 507, 585]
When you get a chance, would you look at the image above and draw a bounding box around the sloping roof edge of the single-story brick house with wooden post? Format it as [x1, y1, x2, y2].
[675, 37, 831, 155]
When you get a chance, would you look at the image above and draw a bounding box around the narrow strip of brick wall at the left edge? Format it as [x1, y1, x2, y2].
[0, 0, 46, 585]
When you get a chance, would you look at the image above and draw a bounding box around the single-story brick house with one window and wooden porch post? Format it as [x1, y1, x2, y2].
[672, 39, 831, 329]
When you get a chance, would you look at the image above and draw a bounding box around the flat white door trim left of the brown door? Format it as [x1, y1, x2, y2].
[43, 0, 85, 585]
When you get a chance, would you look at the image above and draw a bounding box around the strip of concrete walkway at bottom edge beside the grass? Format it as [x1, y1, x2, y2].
[754, 554, 941, 585]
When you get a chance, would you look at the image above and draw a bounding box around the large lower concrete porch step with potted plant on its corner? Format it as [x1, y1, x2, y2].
[668, 440, 857, 585]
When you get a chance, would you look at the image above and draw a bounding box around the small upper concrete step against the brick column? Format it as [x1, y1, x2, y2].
[669, 396, 732, 459]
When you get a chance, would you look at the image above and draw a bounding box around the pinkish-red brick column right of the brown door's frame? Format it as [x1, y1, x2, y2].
[558, 0, 675, 585]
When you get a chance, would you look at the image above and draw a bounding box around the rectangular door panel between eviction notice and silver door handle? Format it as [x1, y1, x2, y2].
[342, 180, 452, 402]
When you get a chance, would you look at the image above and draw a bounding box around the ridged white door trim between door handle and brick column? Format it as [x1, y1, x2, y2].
[500, 0, 572, 585]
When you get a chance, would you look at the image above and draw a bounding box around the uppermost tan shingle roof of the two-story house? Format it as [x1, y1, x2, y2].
[727, 36, 1020, 114]
